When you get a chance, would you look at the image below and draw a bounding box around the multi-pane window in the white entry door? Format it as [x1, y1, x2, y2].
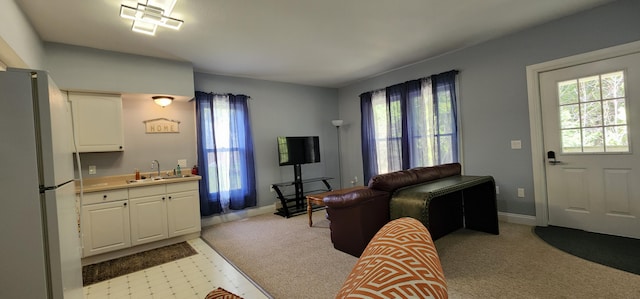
[558, 71, 629, 153]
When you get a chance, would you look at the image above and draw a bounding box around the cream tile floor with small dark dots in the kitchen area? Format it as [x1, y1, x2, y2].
[84, 238, 270, 299]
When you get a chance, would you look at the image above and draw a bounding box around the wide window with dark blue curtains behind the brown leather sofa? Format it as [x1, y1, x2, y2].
[360, 71, 458, 180]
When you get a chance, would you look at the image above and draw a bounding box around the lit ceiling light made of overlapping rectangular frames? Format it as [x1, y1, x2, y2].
[120, 0, 184, 35]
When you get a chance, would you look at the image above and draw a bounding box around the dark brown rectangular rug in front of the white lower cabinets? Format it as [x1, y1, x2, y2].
[82, 242, 198, 286]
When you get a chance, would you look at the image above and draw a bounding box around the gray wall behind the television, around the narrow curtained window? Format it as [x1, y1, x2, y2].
[195, 73, 338, 206]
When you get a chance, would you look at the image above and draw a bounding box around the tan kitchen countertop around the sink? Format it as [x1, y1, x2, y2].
[75, 174, 202, 193]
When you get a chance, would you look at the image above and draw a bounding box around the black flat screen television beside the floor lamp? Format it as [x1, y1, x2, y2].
[278, 136, 320, 166]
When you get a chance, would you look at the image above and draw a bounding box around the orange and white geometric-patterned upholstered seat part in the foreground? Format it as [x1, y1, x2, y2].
[336, 217, 449, 299]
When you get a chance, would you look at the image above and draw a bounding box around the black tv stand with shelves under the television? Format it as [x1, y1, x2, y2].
[271, 173, 333, 218]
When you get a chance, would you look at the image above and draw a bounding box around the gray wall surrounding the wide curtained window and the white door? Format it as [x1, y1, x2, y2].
[339, 0, 640, 215]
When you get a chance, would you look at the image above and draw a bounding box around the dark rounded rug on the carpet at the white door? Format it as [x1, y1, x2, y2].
[534, 226, 640, 275]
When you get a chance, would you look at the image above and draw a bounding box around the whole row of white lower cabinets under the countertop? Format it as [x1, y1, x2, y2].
[81, 181, 201, 257]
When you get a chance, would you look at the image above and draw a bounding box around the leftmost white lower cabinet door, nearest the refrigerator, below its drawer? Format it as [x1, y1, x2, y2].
[82, 200, 131, 257]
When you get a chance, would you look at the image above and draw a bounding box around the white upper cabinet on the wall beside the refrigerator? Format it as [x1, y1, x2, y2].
[69, 92, 124, 153]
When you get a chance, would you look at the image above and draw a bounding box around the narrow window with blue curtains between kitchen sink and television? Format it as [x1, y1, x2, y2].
[196, 91, 257, 216]
